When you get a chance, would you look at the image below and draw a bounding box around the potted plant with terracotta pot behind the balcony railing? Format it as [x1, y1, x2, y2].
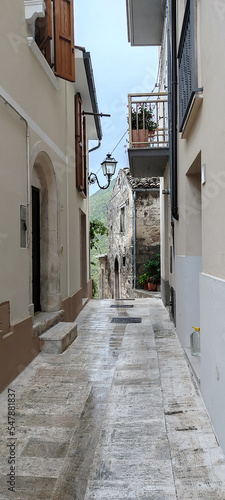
[131, 103, 157, 148]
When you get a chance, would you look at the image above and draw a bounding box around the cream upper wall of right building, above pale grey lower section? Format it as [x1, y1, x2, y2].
[176, 2, 225, 278]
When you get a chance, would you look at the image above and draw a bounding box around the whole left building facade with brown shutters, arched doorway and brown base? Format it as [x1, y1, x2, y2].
[0, 0, 102, 389]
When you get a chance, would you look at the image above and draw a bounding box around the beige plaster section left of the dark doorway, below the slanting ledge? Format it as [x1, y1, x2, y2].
[0, 102, 29, 320]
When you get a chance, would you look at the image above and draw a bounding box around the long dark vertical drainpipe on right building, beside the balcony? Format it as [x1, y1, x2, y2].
[170, 0, 179, 220]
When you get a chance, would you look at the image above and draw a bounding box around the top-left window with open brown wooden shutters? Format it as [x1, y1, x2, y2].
[35, 0, 75, 82]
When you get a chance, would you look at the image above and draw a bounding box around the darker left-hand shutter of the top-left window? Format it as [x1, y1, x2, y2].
[35, 0, 52, 65]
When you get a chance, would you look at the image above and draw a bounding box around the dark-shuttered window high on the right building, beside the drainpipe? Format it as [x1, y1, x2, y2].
[178, 0, 197, 132]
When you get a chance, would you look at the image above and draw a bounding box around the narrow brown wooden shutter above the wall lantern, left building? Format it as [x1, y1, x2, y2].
[75, 94, 84, 191]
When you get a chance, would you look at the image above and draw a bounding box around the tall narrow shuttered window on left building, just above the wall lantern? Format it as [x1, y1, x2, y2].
[75, 94, 87, 196]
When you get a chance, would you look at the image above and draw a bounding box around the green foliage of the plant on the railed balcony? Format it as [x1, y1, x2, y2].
[131, 104, 157, 132]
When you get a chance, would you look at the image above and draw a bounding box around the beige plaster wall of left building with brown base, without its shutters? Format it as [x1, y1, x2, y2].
[0, 0, 98, 387]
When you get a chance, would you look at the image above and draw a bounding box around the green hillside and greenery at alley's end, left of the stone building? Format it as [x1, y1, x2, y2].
[90, 179, 116, 297]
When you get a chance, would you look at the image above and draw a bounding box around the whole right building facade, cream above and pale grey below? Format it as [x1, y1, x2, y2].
[127, 0, 225, 450]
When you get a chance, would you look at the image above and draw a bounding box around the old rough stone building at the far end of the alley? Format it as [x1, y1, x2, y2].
[99, 169, 160, 298]
